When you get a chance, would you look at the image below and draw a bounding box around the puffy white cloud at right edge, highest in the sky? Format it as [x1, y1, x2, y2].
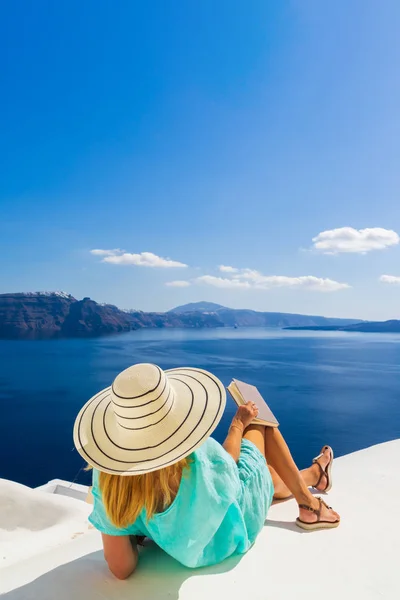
[312, 227, 400, 254]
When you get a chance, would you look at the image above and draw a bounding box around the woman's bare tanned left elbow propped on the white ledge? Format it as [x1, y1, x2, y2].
[101, 533, 139, 579]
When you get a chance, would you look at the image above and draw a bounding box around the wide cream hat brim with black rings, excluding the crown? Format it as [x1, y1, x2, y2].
[74, 367, 226, 475]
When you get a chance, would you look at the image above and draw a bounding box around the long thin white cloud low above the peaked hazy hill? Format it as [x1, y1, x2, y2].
[195, 269, 350, 292]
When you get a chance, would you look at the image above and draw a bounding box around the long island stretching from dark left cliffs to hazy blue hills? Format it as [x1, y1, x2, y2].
[0, 292, 360, 340]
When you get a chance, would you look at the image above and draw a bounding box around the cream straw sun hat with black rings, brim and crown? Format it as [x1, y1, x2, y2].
[74, 364, 226, 475]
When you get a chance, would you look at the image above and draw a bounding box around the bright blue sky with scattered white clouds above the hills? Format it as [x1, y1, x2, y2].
[0, 0, 400, 319]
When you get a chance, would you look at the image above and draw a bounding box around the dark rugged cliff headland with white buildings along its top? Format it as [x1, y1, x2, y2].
[0, 292, 224, 339]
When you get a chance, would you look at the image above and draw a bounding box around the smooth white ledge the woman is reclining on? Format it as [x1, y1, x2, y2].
[0, 440, 400, 600]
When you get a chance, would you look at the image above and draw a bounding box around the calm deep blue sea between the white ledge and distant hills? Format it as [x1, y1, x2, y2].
[0, 329, 400, 486]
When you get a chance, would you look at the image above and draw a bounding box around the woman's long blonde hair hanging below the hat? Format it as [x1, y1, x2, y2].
[99, 457, 191, 528]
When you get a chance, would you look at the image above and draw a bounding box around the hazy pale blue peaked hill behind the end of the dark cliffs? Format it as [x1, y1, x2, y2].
[169, 302, 360, 327]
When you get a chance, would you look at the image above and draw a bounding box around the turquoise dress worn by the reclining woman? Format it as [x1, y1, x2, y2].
[89, 438, 274, 568]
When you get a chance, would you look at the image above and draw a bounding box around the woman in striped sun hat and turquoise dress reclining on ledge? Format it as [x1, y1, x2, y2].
[74, 364, 339, 579]
